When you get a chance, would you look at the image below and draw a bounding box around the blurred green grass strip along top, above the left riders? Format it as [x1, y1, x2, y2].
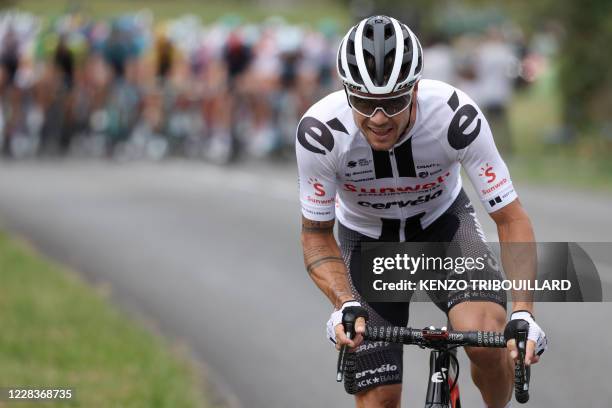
[5, 0, 349, 27]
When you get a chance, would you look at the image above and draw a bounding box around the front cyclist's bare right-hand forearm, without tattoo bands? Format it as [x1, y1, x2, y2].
[497, 207, 537, 313]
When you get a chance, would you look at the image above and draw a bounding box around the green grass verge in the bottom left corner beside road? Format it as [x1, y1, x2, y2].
[0, 233, 208, 408]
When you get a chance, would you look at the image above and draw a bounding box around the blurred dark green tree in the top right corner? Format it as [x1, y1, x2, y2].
[492, 0, 612, 131]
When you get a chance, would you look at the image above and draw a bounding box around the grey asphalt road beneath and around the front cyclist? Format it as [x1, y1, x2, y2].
[0, 162, 612, 408]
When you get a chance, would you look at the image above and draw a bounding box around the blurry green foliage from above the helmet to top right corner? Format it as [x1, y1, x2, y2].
[341, 0, 612, 132]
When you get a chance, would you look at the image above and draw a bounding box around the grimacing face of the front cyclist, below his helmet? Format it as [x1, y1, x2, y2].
[353, 84, 418, 150]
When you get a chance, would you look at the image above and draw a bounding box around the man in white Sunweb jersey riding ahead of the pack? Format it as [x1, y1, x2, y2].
[296, 16, 546, 408]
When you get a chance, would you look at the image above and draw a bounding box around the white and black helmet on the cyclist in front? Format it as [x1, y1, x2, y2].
[338, 16, 423, 95]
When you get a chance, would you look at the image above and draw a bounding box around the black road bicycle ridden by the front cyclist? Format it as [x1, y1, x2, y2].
[336, 312, 531, 408]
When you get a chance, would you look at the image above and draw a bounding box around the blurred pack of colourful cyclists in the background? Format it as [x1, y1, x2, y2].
[0, 11, 556, 162]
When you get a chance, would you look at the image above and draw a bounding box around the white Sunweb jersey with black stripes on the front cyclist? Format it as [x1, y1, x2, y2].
[296, 80, 517, 241]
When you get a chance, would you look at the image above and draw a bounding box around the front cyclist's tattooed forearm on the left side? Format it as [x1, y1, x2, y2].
[302, 217, 353, 309]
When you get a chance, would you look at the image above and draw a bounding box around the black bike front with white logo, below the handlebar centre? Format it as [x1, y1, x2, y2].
[425, 349, 461, 408]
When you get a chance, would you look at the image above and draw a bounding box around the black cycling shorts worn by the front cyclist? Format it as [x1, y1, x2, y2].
[338, 190, 506, 392]
